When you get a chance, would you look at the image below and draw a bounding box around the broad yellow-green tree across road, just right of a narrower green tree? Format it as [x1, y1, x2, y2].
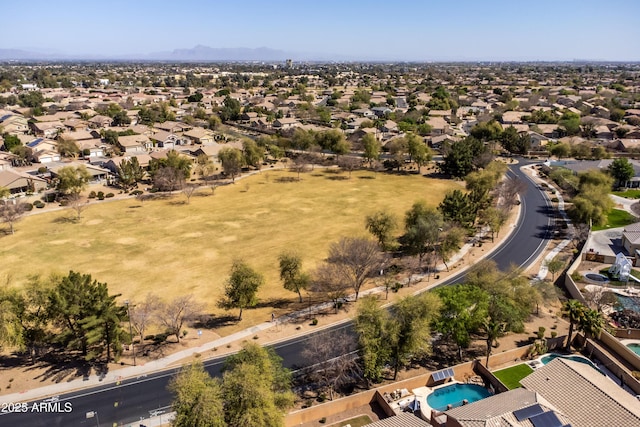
[387, 293, 441, 381]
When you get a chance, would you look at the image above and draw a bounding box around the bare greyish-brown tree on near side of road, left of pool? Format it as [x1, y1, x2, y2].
[302, 332, 360, 400]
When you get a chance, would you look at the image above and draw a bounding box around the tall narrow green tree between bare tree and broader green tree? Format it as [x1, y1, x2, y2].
[354, 295, 391, 387]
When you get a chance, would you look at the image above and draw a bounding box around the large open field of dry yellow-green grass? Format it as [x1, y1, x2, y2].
[0, 170, 460, 333]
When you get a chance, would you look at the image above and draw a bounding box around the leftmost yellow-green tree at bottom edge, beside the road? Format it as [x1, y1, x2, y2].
[169, 361, 227, 427]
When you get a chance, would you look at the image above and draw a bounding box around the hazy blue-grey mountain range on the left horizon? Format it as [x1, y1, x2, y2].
[0, 45, 302, 62]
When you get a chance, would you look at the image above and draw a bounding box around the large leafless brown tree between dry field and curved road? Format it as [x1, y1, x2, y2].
[327, 237, 382, 301]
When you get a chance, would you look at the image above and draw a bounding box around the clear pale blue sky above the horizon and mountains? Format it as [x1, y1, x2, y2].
[0, 0, 640, 61]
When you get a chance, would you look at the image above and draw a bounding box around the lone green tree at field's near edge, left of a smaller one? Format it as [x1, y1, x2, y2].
[218, 260, 264, 320]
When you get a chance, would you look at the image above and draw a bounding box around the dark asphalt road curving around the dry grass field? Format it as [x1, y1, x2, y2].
[0, 163, 553, 427]
